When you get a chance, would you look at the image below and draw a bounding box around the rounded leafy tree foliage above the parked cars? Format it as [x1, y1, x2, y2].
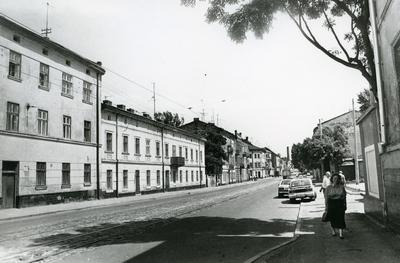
[291, 126, 350, 170]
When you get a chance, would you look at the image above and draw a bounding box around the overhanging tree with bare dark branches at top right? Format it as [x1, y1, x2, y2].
[181, 0, 377, 98]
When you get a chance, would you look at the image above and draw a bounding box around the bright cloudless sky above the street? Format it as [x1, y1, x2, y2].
[0, 0, 368, 155]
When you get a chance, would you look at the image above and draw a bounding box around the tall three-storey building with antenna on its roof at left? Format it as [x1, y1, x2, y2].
[0, 16, 105, 208]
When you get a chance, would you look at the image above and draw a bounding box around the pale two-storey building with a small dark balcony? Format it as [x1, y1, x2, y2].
[100, 101, 206, 197]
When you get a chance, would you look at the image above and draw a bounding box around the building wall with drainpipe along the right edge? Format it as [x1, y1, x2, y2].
[359, 0, 400, 231]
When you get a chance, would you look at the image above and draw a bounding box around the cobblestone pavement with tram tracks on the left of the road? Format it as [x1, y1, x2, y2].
[0, 178, 290, 262]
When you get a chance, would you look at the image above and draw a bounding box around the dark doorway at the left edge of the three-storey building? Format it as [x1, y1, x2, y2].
[1, 161, 19, 208]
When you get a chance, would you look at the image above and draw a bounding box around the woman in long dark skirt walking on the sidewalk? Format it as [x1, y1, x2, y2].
[325, 174, 347, 239]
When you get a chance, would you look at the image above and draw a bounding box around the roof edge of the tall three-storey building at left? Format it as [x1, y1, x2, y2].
[0, 13, 106, 75]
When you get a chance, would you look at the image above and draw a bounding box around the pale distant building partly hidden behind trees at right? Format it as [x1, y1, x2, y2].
[314, 111, 364, 180]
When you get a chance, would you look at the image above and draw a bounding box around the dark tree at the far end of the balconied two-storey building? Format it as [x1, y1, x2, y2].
[205, 130, 228, 175]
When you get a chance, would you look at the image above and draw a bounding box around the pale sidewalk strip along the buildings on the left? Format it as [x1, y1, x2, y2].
[0, 177, 274, 221]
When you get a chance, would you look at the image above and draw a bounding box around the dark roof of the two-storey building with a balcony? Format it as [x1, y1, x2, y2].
[101, 102, 206, 141]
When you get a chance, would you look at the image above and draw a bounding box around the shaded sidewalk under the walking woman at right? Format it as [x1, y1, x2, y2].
[256, 188, 400, 263]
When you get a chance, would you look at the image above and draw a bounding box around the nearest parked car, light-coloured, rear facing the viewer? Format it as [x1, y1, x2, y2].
[289, 177, 317, 202]
